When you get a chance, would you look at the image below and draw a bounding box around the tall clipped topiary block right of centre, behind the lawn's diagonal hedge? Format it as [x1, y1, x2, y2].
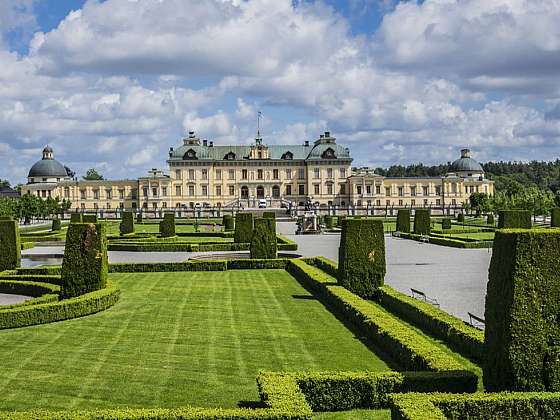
[338, 219, 386, 297]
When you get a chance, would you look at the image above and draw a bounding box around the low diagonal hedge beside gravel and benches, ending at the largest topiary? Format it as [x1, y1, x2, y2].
[379, 286, 485, 362]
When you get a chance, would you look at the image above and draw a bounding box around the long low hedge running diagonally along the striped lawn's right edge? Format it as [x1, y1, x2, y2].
[288, 259, 477, 374]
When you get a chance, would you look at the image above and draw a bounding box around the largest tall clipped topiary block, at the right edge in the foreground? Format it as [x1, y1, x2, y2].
[484, 229, 560, 391]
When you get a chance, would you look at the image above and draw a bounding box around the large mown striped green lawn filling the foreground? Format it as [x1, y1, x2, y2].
[0, 270, 388, 410]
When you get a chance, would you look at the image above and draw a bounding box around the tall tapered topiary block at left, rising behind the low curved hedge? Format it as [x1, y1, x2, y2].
[61, 223, 108, 299]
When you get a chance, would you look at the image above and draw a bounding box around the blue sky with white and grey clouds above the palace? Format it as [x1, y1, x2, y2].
[0, 0, 560, 183]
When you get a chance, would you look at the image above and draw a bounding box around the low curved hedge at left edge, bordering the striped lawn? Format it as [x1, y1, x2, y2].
[0, 282, 119, 330]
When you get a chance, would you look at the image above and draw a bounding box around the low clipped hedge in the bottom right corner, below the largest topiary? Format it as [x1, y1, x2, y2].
[389, 392, 560, 420]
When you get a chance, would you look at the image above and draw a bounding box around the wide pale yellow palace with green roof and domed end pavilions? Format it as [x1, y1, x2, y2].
[22, 131, 494, 211]
